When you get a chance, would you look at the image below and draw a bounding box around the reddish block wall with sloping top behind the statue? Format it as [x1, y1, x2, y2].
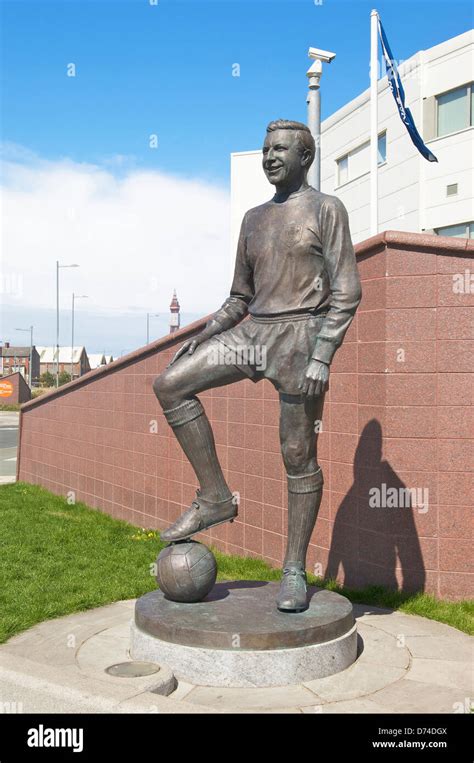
[19, 231, 474, 599]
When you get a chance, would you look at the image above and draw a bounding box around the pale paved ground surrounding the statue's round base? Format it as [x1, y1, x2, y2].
[0, 601, 474, 713]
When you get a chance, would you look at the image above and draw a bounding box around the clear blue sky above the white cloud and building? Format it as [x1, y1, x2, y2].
[2, 0, 472, 185]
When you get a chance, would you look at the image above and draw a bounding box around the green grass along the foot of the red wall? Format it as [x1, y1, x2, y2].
[0, 482, 474, 643]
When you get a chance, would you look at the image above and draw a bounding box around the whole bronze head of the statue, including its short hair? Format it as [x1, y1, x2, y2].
[262, 119, 315, 189]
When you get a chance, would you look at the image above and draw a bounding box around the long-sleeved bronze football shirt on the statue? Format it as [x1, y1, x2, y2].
[209, 186, 361, 363]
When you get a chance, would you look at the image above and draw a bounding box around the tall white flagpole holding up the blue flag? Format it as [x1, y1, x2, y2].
[370, 10, 379, 236]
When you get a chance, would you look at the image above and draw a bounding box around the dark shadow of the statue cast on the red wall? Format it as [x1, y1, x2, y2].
[325, 419, 429, 593]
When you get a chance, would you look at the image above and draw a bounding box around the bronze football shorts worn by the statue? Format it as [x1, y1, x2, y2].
[210, 312, 326, 395]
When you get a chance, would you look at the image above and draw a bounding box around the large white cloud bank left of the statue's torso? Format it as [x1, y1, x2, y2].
[2, 145, 232, 315]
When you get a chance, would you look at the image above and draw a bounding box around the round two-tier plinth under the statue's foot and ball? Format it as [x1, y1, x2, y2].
[130, 581, 357, 687]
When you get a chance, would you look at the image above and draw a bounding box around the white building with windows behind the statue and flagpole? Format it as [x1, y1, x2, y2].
[231, 30, 474, 245]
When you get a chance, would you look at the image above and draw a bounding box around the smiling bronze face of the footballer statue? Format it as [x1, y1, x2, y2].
[262, 130, 306, 187]
